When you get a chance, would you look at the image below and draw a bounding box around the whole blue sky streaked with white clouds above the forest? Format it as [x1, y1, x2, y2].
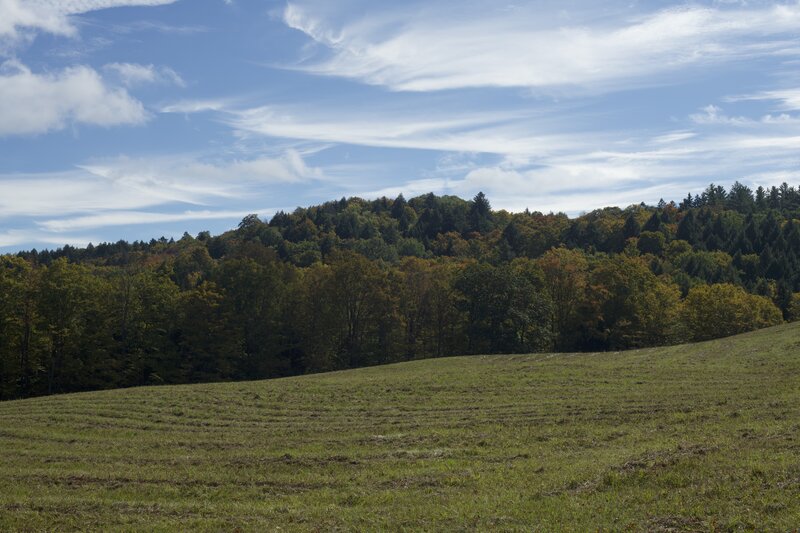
[0, 0, 800, 252]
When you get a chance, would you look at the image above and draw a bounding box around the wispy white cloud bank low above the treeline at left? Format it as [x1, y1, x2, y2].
[0, 150, 325, 248]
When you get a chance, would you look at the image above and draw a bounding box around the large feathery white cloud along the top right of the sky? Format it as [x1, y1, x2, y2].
[283, 1, 800, 91]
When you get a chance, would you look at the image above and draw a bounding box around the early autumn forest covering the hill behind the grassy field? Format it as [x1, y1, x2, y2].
[0, 182, 800, 400]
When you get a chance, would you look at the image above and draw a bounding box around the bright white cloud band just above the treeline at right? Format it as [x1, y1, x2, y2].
[356, 121, 800, 215]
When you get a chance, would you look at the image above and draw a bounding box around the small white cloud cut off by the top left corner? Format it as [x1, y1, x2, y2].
[0, 0, 176, 39]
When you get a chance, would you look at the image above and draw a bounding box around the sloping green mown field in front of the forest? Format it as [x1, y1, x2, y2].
[0, 324, 800, 531]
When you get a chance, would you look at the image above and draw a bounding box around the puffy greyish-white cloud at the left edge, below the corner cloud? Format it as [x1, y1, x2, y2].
[0, 61, 147, 136]
